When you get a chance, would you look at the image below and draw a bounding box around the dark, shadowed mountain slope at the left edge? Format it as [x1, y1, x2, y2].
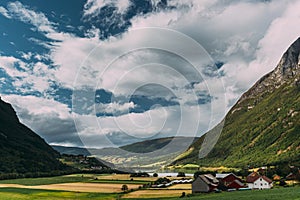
[0, 98, 68, 176]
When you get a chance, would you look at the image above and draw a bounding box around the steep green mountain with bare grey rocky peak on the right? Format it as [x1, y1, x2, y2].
[173, 38, 300, 167]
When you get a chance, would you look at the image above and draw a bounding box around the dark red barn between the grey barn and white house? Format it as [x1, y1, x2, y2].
[216, 173, 245, 190]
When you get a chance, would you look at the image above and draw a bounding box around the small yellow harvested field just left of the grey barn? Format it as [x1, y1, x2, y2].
[123, 190, 191, 198]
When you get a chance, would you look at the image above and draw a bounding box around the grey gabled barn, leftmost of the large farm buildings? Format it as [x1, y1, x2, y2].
[192, 174, 219, 193]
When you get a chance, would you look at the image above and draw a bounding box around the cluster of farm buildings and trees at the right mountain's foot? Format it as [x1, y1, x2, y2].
[142, 166, 300, 194]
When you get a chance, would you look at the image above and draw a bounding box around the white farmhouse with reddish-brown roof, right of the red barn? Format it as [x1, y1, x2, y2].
[246, 172, 273, 190]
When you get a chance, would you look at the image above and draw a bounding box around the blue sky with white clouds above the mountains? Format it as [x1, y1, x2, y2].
[0, 0, 300, 148]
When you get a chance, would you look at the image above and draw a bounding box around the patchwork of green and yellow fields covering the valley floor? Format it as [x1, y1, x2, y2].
[0, 174, 300, 200]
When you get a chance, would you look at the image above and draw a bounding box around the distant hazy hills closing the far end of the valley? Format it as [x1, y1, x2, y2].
[53, 137, 198, 171]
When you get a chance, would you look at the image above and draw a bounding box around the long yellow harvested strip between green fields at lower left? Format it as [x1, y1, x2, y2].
[0, 183, 141, 193]
